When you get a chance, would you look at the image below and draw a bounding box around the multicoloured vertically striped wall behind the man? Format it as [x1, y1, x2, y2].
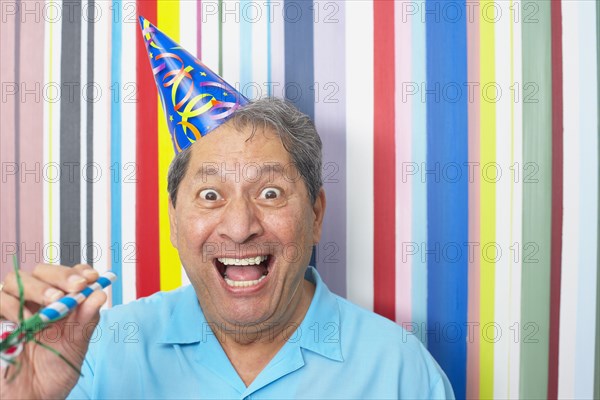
[0, 0, 600, 398]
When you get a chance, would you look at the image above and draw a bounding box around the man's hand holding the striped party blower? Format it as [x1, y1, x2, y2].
[0, 264, 106, 399]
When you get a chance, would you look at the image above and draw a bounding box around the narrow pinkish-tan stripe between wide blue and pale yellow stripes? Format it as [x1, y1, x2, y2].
[467, 6, 481, 399]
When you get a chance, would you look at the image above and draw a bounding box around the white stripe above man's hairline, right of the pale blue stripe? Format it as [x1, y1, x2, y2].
[248, 0, 268, 99]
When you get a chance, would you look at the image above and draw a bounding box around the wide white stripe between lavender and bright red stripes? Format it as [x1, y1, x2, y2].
[344, 1, 374, 310]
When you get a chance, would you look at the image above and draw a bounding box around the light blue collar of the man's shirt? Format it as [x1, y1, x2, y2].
[158, 267, 344, 361]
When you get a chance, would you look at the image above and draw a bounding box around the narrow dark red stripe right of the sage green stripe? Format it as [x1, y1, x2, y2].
[548, 1, 563, 399]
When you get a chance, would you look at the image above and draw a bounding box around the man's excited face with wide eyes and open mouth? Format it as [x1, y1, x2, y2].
[169, 124, 325, 325]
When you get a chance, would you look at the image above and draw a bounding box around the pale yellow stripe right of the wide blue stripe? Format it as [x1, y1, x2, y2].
[479, 0, 496, 399]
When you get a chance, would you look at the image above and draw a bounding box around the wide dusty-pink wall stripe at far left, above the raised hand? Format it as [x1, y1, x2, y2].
[19, 1, 44, 270]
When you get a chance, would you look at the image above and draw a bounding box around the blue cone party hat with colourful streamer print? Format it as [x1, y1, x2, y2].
[140, 17, 248, 153]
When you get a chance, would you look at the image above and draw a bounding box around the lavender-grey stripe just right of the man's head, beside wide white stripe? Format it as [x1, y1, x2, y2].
[314, 1, 346, 297]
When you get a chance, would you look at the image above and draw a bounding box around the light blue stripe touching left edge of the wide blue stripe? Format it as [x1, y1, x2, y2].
[405, 0, 427, 343]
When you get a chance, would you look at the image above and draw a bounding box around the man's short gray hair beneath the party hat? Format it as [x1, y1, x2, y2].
[167, 97, 323, 206]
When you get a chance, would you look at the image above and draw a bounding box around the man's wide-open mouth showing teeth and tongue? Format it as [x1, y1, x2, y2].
[215, 255, 273, 287]
